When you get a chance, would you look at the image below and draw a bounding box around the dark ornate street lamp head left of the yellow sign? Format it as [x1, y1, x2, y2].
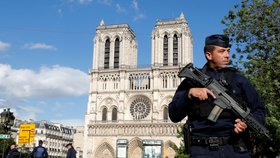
[0, 108, 15, 133]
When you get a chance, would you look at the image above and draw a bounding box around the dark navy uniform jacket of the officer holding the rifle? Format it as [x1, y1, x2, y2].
[168, 65, 265, 136]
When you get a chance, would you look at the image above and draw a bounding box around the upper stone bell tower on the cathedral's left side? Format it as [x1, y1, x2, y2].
[93, 20, 137, 69]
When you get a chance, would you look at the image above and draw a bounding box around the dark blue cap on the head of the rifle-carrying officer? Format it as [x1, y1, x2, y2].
[205, 34, 229, 48]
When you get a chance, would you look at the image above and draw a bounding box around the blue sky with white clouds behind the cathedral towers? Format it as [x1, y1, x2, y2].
[0, 0, 237, 126]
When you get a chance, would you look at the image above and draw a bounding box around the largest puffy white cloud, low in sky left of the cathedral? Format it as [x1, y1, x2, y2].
[0, 64, 89, 98]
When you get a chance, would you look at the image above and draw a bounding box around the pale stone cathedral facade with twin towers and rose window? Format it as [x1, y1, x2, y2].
[83, 13, 193, 158]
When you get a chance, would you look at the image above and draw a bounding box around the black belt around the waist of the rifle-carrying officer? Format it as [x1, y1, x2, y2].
[191, 136, 229, 146]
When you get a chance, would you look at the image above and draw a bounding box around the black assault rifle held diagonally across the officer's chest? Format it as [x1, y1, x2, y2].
[178, 63, 272, 140]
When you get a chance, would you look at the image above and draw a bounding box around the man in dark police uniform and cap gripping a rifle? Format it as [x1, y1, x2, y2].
[168, 34, 265, 158]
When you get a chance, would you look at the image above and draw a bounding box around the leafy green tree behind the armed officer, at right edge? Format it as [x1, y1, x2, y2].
[222, 0, 280, 157]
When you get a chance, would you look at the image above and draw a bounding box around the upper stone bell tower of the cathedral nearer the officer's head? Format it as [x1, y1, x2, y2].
[152, 13, 193, 67]
